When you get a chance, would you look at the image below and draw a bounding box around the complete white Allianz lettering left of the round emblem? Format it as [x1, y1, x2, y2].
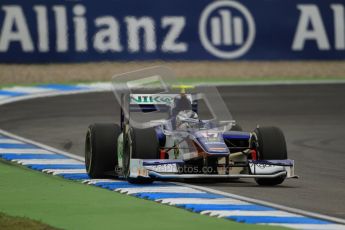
[0, 4, 188, 53]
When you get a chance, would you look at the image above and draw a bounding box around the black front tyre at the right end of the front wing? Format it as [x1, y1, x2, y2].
[254, 127, 287, 186]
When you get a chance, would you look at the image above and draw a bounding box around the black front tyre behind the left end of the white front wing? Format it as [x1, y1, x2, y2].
[123, 127, 160, 184]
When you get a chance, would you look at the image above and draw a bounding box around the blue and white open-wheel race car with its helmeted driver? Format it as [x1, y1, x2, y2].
[85, 67, 296, 185]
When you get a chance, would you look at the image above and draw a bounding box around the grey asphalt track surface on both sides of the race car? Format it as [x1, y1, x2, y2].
[0, 84, 345, 218]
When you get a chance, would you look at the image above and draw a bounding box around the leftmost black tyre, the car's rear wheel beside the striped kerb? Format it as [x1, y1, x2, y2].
[85, 124, 121, 179]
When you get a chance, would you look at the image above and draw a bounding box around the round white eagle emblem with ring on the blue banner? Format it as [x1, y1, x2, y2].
[199, 1, 255, 59]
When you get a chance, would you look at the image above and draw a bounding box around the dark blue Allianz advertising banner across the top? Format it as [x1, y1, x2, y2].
[0, 0, 345, 63]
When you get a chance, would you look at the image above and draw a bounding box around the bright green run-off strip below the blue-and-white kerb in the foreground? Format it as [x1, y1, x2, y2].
[0, 160, 282, 230]
